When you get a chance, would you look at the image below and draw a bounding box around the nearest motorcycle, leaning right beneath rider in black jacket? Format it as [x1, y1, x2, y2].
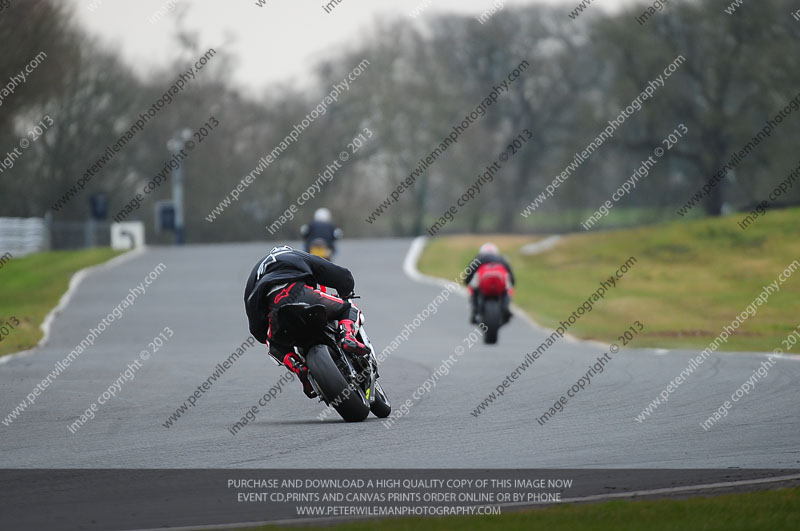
[278, 296, 392, 422]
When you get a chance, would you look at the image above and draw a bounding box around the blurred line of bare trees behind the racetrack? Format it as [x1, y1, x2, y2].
[0, 0, 800, 242]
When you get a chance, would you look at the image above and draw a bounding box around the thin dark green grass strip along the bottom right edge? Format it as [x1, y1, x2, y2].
[239, 488, 800, 531]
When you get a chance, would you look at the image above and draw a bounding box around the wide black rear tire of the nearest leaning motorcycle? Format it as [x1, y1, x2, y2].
[306, 345, 370, 422]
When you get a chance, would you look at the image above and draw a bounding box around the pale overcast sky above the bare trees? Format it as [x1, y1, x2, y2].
[71, 0, 629, 91]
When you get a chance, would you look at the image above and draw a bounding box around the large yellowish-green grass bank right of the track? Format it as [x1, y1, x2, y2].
[419, 209, 800, 351]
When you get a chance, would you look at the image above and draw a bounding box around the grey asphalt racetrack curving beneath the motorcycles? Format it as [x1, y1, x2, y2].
[0, 240, 800, 468]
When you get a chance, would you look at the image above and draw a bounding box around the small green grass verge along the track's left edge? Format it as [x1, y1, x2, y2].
[0, 247, 121, 356]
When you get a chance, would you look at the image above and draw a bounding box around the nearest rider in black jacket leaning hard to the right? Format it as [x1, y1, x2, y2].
[244, 245, 370, 398]
